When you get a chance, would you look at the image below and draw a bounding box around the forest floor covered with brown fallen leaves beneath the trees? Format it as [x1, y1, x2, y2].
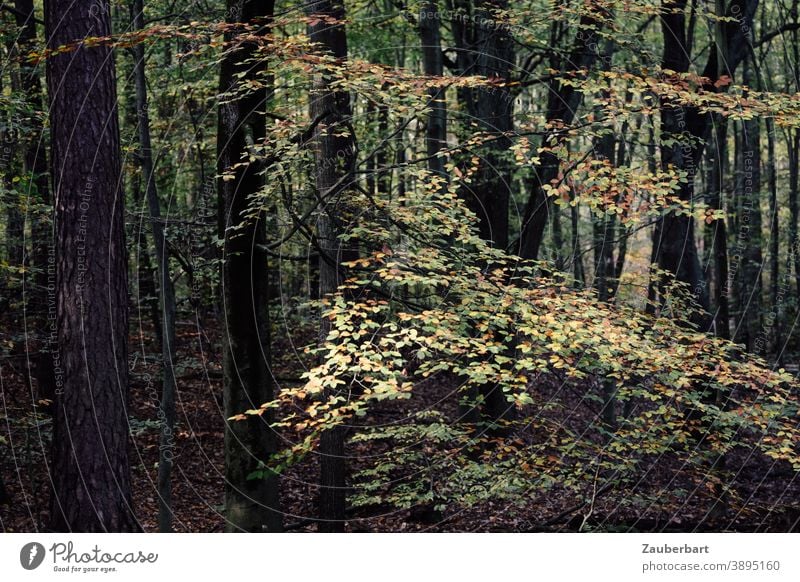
[0, 310, 800, 532]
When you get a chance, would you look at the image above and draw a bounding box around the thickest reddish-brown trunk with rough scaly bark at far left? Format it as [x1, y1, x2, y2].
[45, 0, 140, 532]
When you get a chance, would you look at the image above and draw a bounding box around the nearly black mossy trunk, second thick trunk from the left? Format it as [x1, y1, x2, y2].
[217, 0, 282, 532]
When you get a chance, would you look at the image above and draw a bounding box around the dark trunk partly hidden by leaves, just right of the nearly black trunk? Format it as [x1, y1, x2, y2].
[306, 0, 356, 532]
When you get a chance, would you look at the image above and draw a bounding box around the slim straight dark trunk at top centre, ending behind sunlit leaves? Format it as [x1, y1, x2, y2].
[419, 1, 447, 177]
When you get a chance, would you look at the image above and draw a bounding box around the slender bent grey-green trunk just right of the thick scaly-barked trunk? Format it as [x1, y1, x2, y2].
[133, 0, 177, 532]
